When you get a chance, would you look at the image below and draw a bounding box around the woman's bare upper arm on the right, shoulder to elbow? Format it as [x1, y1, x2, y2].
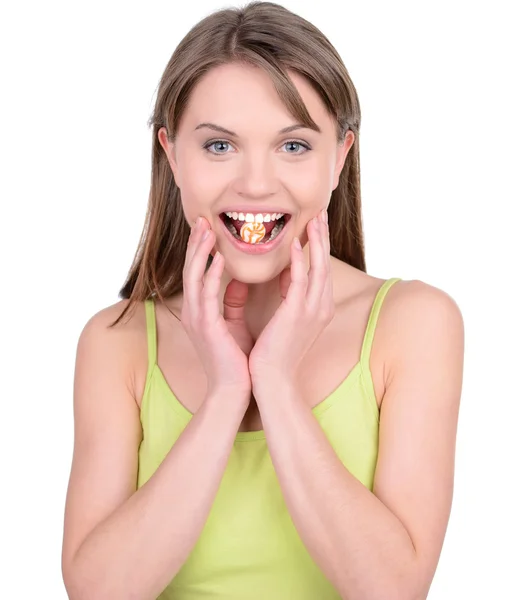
[373, 280, 464, 597]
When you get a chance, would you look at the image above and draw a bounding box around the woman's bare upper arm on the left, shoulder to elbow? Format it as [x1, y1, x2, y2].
[62, 303, 142, 579]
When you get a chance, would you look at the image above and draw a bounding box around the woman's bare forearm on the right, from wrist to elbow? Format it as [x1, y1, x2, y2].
[254, 385, 416, 600]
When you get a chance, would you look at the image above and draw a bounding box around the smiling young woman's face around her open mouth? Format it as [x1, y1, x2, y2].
[159, 64, 354, 283]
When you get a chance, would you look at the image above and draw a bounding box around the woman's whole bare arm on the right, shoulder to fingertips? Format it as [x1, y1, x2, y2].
[187, 202, 464, 600]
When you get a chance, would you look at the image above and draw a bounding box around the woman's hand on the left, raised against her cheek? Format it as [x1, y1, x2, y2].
[181, 217, 254, 408]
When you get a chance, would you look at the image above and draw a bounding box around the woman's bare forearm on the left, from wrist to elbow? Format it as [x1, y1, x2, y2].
[69, 394, 245, 600]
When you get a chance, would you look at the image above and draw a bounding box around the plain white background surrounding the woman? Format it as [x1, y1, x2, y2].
[0, 0, 508, 600]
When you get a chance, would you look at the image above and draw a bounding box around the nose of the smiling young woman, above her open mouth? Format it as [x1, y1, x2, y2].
[234, 152, 279, 198]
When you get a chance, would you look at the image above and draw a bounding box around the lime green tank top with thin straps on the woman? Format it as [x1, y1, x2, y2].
[138, 278, 400, 600]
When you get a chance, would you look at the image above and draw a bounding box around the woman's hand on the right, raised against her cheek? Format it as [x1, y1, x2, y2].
[249, 209, 335, 388]
